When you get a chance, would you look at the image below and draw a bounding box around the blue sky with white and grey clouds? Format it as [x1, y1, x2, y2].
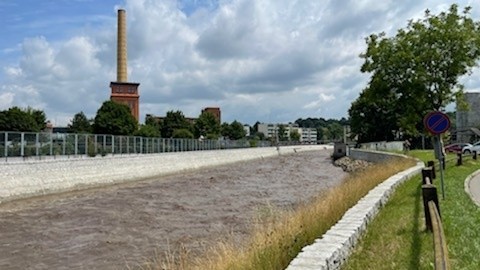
[0, 0, 480, 126]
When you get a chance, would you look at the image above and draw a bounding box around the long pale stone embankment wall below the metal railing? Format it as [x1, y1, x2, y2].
[0, 145, 331, 203]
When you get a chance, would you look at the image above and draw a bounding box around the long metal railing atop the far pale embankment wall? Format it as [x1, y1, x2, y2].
[0, 131, 280, 159]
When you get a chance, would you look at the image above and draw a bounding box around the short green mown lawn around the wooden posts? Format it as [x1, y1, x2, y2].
[343, 150, 480, 270]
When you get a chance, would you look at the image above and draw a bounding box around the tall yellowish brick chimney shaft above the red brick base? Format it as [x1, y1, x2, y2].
[117, 9, 128, 82]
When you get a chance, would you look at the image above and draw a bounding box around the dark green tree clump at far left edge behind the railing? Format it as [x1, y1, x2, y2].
[0, 107, 46, 132]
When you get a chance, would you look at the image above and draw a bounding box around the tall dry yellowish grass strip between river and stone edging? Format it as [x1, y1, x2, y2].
[143, 155, 415, 270]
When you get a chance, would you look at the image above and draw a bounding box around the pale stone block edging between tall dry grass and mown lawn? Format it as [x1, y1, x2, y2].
[286, 152, 425, 270]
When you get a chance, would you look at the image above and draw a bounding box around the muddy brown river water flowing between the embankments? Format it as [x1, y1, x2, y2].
[0, 150, 346, 270]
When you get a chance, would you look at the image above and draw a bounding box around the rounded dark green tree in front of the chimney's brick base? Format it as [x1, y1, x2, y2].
[93, 100, 138, 135]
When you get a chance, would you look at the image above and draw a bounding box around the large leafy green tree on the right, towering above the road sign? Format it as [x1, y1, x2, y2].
[356, 4, 480, 136]
